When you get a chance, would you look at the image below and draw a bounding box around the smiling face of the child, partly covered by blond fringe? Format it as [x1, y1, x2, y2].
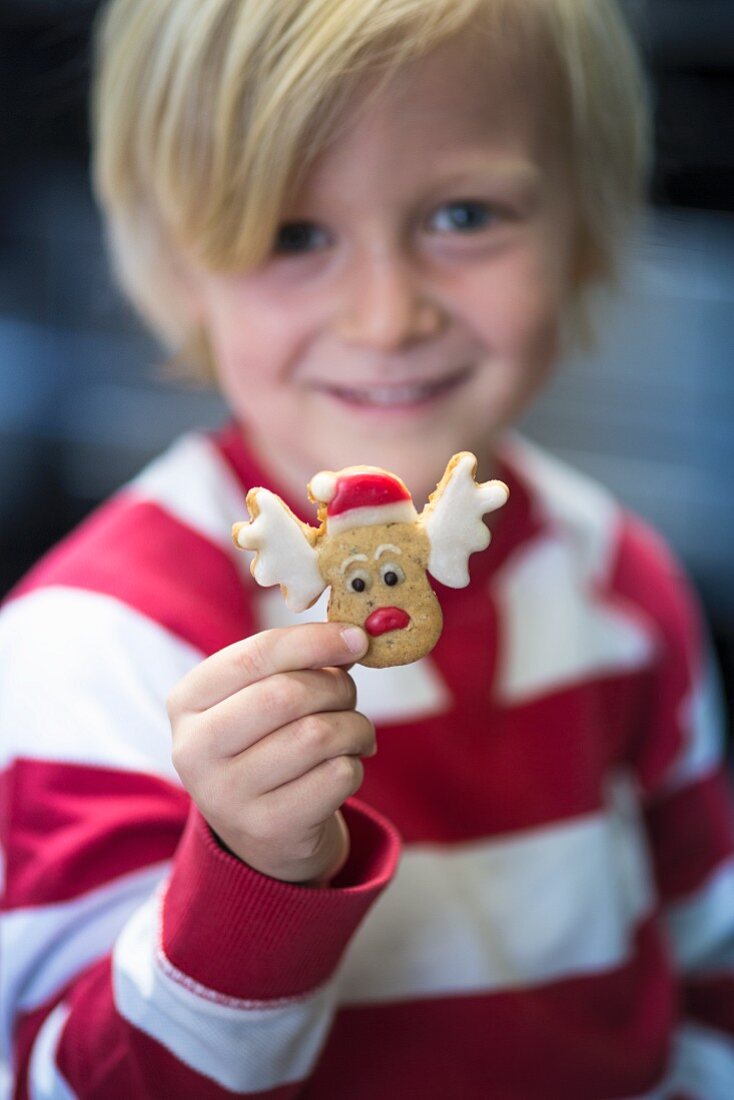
[189, 36, 576, 494]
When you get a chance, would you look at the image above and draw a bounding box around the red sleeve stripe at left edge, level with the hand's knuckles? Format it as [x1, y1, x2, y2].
[2, 760, 189, 910]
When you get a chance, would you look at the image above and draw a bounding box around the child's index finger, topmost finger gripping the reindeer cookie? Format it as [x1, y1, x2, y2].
[170, 623, 369, 712]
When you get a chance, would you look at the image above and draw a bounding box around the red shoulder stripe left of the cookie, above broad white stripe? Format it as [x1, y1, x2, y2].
[6, 492, 253, 655]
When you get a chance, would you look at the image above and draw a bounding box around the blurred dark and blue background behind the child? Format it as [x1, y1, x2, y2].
[0, 0, 734, 734]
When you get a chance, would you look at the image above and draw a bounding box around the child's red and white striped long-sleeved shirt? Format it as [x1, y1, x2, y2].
[0, 428, 734, 1100]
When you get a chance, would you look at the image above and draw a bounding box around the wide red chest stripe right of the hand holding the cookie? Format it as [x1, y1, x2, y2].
[360, 674, 643, 844]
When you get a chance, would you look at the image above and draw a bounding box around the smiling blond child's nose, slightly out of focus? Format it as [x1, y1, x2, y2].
[337, 253, 447, 352]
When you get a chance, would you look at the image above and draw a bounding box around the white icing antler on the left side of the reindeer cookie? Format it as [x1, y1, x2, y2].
[232, 488, 326, 612]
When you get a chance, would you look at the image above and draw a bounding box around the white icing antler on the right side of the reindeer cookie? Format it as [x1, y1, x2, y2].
[420, 451, 510, 589]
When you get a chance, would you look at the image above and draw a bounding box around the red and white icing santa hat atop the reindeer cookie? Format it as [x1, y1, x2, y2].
[308, 466, 418, 535]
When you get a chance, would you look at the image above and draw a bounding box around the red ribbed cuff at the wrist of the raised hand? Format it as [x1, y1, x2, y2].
[162, 800, 399, 1000]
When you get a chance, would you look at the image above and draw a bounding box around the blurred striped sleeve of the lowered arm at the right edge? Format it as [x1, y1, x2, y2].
[620, 525, 734, 1097]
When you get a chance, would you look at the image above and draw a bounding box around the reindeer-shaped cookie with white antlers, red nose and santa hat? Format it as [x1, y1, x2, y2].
[232, 451, 508, 668]
